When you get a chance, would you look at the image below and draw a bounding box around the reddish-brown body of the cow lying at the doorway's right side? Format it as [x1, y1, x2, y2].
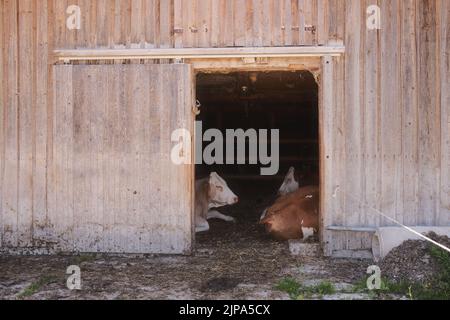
[260, 186, 319, 240]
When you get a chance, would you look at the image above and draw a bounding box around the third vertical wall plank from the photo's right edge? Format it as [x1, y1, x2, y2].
[401, 0, 419, 226]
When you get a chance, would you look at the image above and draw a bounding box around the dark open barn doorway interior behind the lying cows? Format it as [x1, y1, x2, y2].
[196, 71, 320, 244]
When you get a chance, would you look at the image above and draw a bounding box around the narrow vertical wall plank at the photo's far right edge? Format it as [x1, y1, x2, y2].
[438, 1, 450, 226]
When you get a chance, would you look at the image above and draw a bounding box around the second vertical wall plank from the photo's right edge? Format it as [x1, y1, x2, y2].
[417, 0, 441, 225]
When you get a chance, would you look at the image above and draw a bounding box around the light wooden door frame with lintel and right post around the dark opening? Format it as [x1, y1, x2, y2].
[188, 55, 336, 256]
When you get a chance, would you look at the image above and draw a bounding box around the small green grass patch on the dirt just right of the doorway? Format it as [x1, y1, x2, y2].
[275, 278, 336, 300]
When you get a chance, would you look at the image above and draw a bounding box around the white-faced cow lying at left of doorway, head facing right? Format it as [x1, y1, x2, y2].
[195, 172, 239, 232]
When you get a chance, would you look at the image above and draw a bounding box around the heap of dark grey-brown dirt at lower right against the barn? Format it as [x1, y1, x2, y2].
[380, 232, 450, 286]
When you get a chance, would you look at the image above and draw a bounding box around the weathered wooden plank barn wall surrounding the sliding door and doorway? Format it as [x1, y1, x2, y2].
[0, 0, 450, 254]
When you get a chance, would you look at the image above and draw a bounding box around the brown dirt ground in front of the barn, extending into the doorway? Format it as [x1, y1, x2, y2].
[0, 184, 394, 300]
